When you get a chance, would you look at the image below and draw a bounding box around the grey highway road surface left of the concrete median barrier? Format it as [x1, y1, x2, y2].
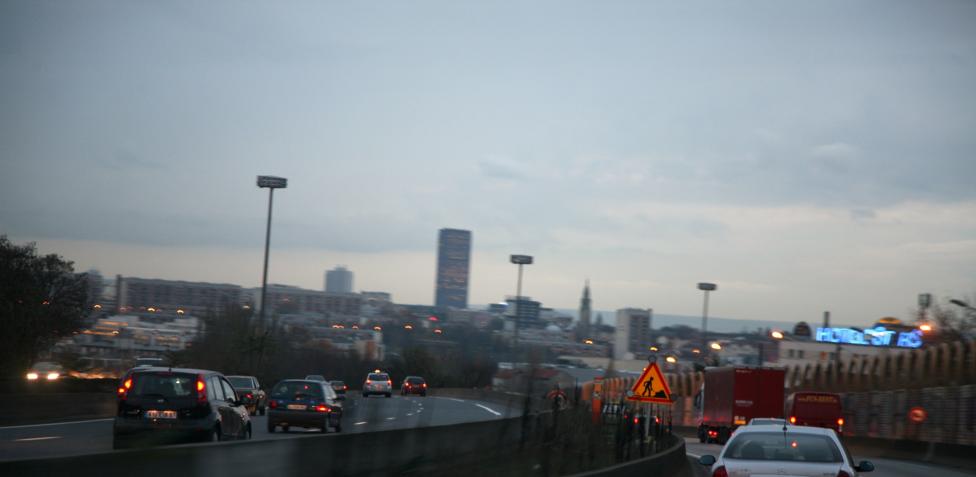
[0, 394, 520, 461]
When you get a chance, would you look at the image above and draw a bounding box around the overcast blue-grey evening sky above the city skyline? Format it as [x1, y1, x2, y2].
[0, 0, 976, 324]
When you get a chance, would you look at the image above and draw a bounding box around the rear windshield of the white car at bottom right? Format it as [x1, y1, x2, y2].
[722, 432, 843, 463]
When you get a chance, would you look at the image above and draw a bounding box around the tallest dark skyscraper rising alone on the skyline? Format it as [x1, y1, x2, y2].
[434, 229, 471, 308]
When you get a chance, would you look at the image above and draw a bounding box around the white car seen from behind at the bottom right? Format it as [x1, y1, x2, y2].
[698, 425, 874, 477]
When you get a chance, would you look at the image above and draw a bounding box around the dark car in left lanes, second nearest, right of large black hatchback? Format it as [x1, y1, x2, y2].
[268, 379, 342, 433]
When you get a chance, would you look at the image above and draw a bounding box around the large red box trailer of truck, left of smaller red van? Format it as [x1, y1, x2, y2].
[698, 366, 786, 444]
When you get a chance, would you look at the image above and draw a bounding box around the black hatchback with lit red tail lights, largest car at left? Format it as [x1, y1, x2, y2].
[112, 367, 251, 449]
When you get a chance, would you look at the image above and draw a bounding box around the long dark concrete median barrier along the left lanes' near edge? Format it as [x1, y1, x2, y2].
[0, 410, 520, 477]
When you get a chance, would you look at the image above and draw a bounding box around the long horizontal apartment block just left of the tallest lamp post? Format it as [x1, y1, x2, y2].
[116, 275, 243, 316]
